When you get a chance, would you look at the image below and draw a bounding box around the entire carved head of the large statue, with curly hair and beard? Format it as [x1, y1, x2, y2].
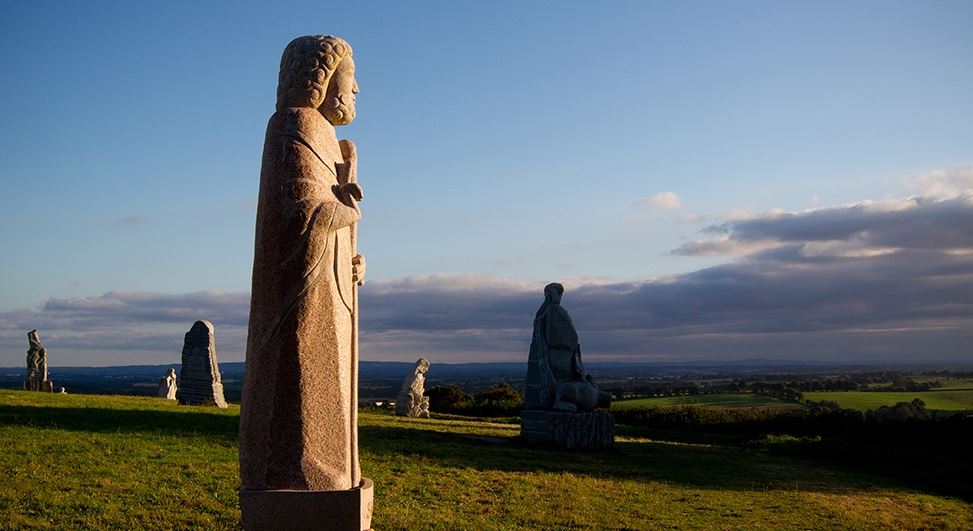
[277, 35, 358, 125]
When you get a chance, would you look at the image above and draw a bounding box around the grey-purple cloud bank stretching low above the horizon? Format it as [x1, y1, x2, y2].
[0, 169, 973, 366]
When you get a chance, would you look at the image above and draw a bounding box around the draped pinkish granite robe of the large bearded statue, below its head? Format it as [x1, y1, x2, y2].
[240, 108, 361, 490]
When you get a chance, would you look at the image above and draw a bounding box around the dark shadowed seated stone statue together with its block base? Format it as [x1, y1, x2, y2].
[521, 283, 614, 449]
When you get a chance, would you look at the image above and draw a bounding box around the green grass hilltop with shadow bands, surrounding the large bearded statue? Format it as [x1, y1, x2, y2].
[0, 390, 973, 529]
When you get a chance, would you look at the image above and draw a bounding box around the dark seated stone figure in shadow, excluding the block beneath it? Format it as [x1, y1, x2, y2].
[524, 283, 611, 412]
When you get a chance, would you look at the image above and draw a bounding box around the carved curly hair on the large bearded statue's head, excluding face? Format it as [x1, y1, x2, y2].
[277, 35, 351, 110]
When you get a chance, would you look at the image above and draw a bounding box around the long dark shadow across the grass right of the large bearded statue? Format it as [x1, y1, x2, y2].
[359, 426, 973, 501]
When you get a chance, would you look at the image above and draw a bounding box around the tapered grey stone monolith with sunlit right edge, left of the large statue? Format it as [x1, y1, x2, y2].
[176, 321, 226, 407]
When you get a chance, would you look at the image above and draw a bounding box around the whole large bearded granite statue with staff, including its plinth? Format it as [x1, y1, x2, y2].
[240, 35, 372, 530]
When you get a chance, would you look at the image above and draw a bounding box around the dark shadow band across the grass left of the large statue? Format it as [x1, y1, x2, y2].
[0, 405, 240, 445]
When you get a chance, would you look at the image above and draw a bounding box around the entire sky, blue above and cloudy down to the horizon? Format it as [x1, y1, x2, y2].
[0, 2, 973, 366]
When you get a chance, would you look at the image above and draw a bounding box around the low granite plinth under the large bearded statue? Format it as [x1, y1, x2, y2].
[240, 478, 374, 531]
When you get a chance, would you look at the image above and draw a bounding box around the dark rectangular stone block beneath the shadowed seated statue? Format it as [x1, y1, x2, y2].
[520, 409, 615, 450]
